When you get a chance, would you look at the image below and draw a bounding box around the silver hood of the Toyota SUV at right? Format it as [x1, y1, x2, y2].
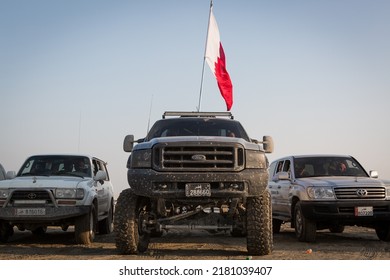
[296, 177, 390, 187]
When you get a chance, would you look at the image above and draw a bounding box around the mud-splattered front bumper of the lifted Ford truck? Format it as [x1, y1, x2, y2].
[127, 169, 268, 198]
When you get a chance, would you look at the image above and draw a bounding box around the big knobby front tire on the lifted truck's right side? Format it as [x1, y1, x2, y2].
[246, 191, 273, 256]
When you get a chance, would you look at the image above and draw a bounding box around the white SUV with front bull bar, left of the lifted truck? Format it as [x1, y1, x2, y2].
[0, 154, 114, 244]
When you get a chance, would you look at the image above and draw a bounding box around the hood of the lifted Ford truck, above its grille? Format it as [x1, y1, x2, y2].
[134, 136, 262, 150]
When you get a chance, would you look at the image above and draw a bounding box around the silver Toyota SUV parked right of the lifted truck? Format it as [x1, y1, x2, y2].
[268, 155, 390, 242]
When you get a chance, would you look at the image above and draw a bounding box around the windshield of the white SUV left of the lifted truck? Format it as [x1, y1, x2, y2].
[17, 155, 92, 177]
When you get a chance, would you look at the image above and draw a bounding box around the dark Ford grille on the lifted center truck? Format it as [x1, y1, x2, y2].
[153, 144, 244, 171]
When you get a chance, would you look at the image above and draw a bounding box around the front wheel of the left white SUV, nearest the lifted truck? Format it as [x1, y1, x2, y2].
[74, 204, 96, 245]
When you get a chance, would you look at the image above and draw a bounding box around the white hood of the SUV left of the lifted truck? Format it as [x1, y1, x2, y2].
[0, 176, 92, 189]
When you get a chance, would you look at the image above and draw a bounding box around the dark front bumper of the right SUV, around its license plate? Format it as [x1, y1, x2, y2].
[301, 200, 390, 225]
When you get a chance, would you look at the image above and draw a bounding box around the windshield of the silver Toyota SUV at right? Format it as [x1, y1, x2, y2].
[294, 157, 368, 178]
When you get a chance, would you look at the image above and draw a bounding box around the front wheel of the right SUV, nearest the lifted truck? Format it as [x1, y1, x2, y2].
[294, 201, 317, 242]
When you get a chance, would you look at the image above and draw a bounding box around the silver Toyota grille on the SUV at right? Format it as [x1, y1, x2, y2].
[334, 187, 386, 199]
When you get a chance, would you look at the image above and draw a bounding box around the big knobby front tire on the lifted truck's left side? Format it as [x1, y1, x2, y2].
[114, 189, 150, 255]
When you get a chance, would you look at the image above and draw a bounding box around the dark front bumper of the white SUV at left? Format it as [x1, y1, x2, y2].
[0, 206, 91, 223]
